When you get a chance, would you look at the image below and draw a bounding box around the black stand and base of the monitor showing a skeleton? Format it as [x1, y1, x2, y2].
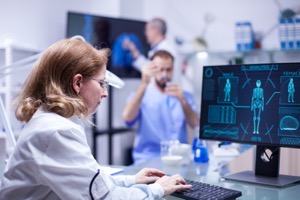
[223, 145, 300, 187]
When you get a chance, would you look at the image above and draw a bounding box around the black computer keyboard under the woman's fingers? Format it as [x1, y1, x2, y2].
[171, 180, 242, 200]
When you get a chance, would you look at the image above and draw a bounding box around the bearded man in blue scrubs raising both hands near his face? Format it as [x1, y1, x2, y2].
[123, 50, 199, 164]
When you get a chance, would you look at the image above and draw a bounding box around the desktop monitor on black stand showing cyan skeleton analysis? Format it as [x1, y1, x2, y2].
[199, 63, 300, 186]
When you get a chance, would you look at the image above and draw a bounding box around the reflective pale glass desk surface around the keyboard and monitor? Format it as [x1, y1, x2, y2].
[119, 147, 300, 200]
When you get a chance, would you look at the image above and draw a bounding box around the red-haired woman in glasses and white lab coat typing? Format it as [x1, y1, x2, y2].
[0, 39, 191, 200]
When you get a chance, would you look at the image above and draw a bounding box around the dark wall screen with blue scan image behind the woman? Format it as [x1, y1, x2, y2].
[66, 12, 149, 78]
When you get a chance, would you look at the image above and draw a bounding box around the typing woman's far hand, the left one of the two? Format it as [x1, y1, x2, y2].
[135, 168, 165, 184]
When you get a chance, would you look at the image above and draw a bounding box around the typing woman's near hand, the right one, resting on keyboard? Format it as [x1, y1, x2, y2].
[155, 174, 192, 196]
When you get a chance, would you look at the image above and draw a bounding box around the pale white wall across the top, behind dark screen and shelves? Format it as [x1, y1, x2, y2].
[0, 0, 300, 51]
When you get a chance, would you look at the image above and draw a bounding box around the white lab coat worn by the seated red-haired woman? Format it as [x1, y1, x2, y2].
[0, 109, 163, 200]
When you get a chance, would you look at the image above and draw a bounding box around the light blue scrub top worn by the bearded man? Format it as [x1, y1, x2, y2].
[126, 84, 197, 164]
